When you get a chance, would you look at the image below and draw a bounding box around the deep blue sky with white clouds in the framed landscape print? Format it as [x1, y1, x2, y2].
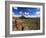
[12, 7, 40, 16]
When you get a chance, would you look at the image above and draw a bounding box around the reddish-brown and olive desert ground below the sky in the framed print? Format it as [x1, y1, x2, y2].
[12, 16, 40, 31]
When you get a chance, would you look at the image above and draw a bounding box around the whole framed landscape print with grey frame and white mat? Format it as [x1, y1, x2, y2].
[5, 1, 45, 37]
